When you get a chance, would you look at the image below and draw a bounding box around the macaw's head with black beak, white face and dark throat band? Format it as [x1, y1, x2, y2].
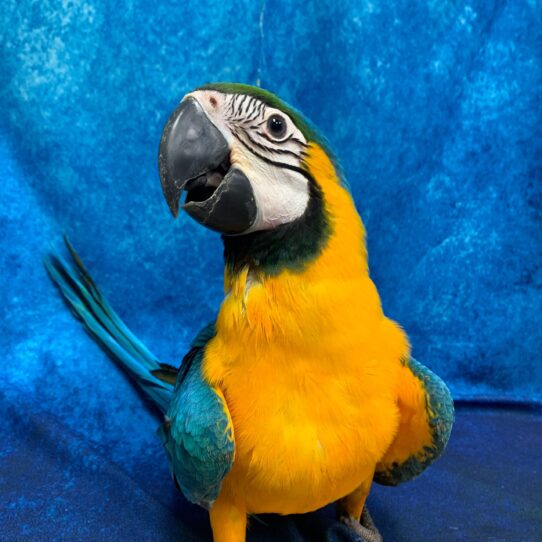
[159, 83, 360, 276]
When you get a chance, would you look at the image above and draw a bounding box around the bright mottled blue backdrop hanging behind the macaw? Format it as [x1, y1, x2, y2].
[0, 0, 542, 540]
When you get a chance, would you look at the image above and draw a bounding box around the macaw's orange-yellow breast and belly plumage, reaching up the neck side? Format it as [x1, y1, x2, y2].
[203, 145, 409, 514]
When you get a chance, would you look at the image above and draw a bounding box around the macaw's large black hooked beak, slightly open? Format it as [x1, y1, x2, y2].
[158, 97, 257, 234]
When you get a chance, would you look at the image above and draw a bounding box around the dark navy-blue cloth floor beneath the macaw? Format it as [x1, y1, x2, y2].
[0, 403, 542, 542]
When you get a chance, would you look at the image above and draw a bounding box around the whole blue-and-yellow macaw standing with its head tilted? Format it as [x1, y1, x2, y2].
[47, 83, 454, 542]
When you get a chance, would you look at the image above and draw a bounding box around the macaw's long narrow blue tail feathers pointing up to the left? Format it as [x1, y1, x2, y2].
[45, 238, 177, 413]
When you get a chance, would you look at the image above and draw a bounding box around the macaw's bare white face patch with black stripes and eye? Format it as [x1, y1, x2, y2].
[187, 90, 310, 233]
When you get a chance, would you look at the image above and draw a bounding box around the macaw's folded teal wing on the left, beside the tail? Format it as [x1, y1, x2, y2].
[158, 324, 235, 508]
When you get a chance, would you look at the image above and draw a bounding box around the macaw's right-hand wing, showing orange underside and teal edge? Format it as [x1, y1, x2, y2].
[374, 358, 454, 486]
